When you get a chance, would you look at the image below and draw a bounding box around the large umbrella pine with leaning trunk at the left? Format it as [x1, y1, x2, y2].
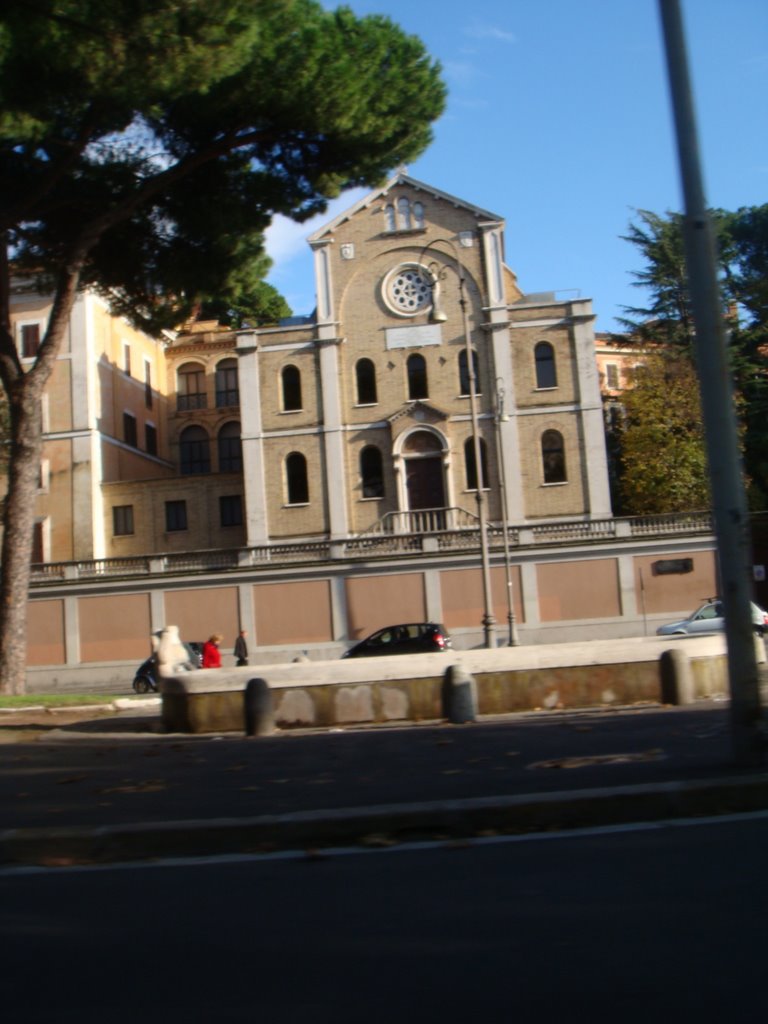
[0, 0, 445, 690]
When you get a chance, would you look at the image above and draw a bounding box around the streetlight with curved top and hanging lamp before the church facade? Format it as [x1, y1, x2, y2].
[419, 239, 496, 647]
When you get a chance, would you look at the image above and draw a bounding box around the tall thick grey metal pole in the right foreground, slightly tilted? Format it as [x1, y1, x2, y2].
[659, 0, 765, 767]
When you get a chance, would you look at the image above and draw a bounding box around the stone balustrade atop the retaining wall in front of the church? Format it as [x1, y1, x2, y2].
[27, 508, 713, 586]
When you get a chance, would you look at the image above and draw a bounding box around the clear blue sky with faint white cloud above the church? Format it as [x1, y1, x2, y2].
[267, 0, 768, 331]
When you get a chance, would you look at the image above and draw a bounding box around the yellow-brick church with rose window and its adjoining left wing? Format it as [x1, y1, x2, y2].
[7, 173, 611, 561]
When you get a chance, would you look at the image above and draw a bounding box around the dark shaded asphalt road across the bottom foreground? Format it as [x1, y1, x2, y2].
[0, 814, 768, 1024]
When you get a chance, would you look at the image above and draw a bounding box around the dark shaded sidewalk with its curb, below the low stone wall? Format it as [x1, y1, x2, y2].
[0, 702, 768, 865]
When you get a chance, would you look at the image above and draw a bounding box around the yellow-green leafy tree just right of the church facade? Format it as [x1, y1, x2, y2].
[620, 351, 710, 515]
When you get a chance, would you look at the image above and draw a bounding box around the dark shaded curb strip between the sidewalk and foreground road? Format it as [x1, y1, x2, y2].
[0, 773, 768, 867]
